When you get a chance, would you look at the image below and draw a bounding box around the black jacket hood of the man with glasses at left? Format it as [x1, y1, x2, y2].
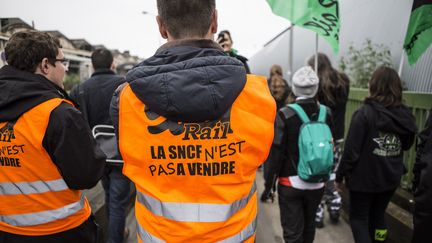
[0, 65, 69, 122]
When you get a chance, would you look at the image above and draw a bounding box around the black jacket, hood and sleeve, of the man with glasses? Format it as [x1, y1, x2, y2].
[0, 65, 105, 190]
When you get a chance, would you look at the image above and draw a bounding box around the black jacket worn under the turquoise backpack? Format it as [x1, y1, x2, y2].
[265, 99, 332, 190]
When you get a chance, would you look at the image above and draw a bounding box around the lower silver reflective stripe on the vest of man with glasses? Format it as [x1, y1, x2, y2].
[0, 196, 85, 226]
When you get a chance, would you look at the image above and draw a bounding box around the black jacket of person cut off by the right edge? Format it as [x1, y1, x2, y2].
[413, 111, 432, 214]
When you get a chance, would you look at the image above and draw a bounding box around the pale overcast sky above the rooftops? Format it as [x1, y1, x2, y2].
[0, 0, 289, 57]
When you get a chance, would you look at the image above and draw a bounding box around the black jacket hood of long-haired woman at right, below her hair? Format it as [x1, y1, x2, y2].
[365, 100, 417, 135]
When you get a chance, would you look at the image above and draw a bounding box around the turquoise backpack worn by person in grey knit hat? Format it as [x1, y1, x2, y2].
[288, 104, 334, 182]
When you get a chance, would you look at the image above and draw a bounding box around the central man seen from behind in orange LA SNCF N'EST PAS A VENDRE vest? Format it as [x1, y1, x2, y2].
[111, 0, 276, 242]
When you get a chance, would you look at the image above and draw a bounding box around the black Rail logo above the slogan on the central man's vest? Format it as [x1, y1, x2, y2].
[144, 109, 233, 140]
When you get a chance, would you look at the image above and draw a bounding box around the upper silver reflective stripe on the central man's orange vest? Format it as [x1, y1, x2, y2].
[137, 183, 256, 223]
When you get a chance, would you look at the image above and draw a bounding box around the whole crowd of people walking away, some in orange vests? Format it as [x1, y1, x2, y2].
[0, 0, 432, 243]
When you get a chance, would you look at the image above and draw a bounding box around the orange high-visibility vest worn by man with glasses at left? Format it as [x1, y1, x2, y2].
[0, 98, 91, 236]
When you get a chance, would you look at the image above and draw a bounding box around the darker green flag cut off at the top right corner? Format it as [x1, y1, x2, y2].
[404, 0, 432, 65]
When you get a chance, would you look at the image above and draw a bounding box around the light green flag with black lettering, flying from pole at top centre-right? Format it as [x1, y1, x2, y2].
[267, 0, 340, 53]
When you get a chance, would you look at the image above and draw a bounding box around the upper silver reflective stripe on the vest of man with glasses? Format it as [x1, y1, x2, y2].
[0, 179, 69, 195]
